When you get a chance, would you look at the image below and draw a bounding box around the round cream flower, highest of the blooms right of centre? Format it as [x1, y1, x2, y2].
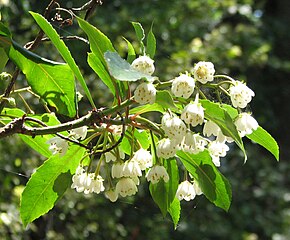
[193, 62, 215, 84]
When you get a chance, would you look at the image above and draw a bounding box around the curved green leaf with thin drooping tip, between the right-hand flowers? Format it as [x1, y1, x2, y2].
[200, 100, 247, 161]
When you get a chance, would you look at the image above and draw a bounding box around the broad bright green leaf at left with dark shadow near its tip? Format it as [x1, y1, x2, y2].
[9, 47, 76, 117]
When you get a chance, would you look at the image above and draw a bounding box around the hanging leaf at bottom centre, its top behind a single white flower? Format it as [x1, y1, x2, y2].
[149, 159, 179, 217]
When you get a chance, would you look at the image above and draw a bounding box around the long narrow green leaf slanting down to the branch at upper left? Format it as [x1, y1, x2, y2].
[30, 12, 95, 107]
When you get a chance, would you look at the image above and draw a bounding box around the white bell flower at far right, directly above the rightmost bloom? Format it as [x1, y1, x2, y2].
[229, 81, 255, 108]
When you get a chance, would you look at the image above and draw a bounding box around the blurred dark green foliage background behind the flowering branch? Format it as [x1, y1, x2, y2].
[0, 0, 290, 240]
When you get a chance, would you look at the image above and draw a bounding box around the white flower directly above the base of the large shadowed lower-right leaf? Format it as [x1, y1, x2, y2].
[181, 132, 207, 154]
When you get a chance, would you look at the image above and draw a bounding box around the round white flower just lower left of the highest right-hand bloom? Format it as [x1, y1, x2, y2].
[171, 74, 195, 99]
